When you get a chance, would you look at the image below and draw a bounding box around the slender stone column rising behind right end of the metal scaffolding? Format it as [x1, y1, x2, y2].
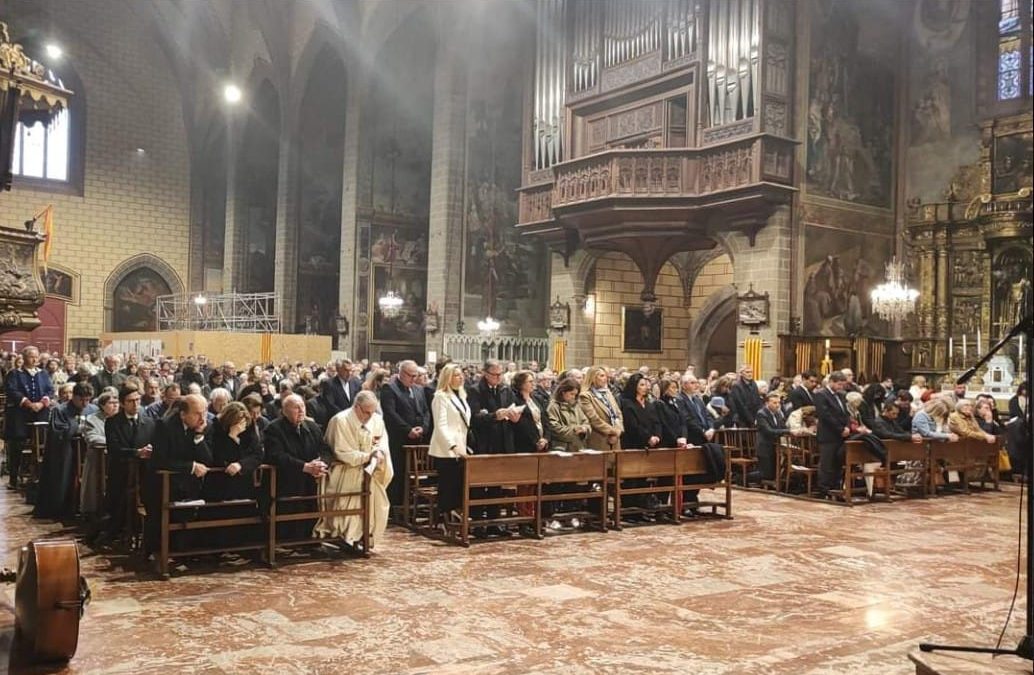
[273, 110, 307, 333]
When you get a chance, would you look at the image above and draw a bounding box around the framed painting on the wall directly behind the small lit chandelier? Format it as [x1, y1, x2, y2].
[370, 265, 427, 344]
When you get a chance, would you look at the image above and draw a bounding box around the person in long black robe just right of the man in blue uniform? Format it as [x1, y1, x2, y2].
[32, 382, 97, 519]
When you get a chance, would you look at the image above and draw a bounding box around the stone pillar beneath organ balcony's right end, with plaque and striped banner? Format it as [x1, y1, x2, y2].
[723, 206, 791, 379]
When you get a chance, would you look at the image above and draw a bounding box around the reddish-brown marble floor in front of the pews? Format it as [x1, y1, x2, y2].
[0, 485, 1031, 675]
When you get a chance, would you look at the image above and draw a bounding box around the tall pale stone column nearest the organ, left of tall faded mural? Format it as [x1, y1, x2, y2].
[426, 5, 472, 354]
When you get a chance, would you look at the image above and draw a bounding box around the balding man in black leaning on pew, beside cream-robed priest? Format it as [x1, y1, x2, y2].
[263, 394, 332, 541]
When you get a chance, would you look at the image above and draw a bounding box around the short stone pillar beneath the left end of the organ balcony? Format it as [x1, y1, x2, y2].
[548, 250, 596, 368]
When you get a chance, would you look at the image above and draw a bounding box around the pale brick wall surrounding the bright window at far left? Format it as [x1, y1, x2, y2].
[0, 0, 189, 339]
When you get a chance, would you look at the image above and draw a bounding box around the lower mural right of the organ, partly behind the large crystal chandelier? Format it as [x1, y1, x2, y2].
[803, 223, 893, 337]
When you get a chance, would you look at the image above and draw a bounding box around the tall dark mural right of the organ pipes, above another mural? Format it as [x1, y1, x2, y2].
[807, 0, 896, 208]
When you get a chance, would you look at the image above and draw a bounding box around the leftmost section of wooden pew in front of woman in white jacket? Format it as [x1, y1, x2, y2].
[459, 453, 542, 546]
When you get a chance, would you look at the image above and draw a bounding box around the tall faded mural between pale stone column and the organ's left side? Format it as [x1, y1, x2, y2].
[463, 3, 548, 330]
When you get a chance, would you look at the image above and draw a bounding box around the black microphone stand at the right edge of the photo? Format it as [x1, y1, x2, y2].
[919, 312, 1034, 661]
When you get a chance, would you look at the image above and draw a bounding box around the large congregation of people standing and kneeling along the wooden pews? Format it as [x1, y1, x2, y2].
[0, 346, 1028, 552]
